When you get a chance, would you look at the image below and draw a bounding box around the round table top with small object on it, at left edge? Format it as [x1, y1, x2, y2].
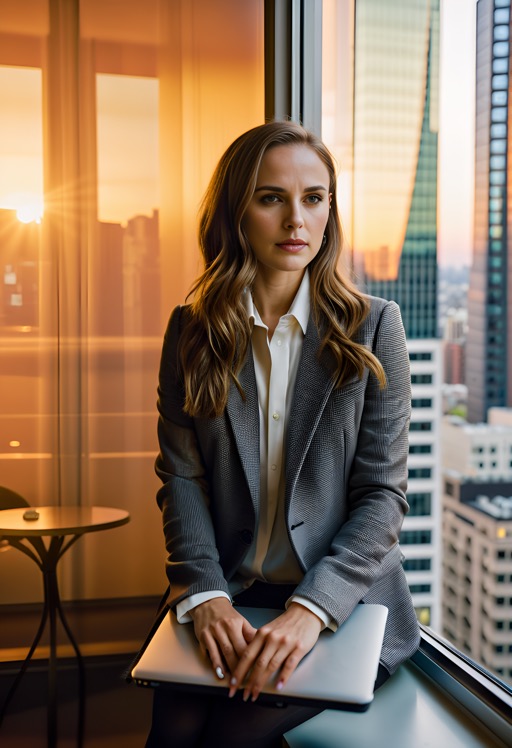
[0, 506, 130, 538]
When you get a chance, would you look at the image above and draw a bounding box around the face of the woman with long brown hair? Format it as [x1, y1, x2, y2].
[242, 145, 331, 278]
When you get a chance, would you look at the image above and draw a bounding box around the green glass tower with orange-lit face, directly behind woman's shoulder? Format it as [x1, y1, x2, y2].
[353, 0, 439, 339]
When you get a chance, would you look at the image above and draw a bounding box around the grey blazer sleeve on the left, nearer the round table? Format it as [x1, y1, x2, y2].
[155, 307, 229, 607]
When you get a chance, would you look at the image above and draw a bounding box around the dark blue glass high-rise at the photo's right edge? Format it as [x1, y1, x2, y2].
[466, 0, 512, 423]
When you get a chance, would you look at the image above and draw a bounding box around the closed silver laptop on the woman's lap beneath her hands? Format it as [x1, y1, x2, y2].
[131, 605, 388, 711]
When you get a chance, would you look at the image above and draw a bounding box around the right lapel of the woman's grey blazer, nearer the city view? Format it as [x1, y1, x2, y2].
[285, 316, 334, 496]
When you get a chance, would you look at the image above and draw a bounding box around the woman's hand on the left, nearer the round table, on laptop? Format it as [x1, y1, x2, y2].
[190, 597, 256, 678]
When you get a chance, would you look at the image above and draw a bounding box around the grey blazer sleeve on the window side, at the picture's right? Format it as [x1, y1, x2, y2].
[296, 302, 411, 625]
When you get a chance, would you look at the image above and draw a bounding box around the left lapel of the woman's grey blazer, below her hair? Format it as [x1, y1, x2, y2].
[226, 346, 260, 508]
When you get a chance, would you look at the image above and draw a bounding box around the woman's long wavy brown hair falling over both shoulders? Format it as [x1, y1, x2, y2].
[179, 121, 386, 418]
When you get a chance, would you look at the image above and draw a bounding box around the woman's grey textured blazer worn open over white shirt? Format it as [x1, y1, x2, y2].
[156, 298, 419, 672]
